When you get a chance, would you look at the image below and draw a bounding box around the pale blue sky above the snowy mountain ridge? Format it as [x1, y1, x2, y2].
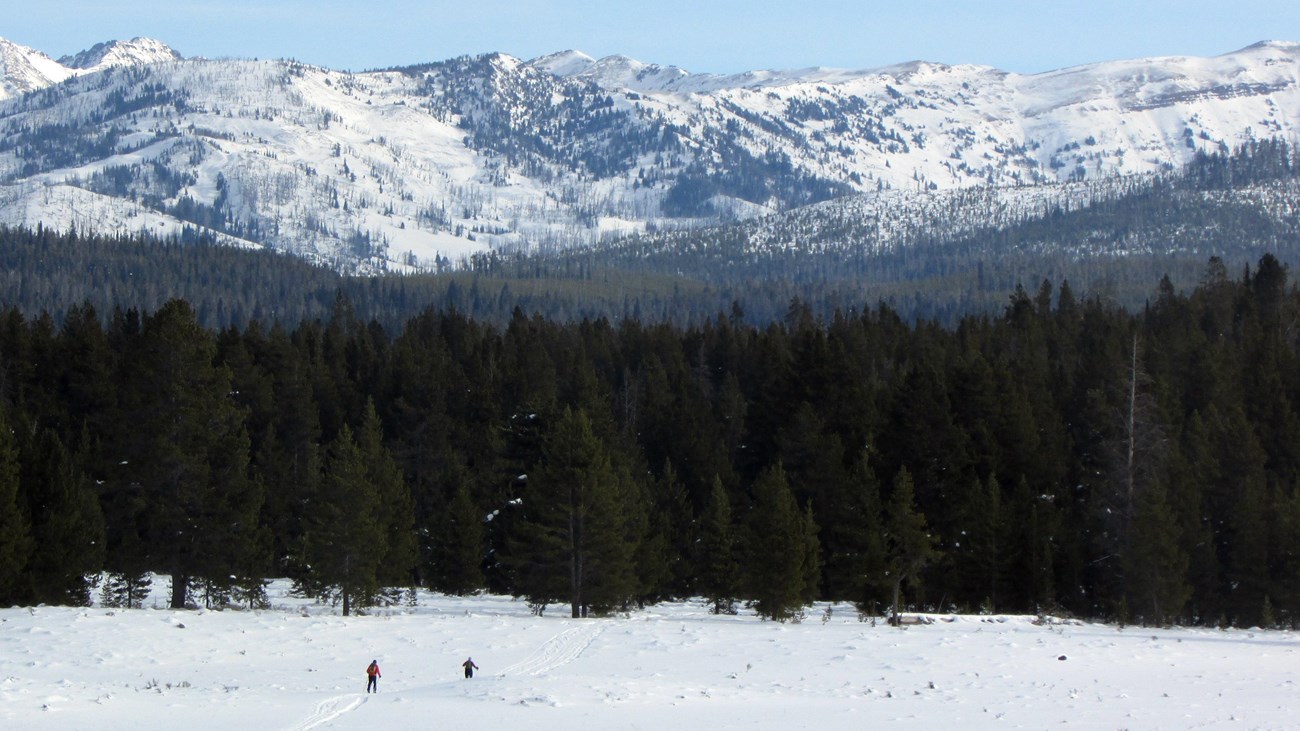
[10, 0, 1300, 73]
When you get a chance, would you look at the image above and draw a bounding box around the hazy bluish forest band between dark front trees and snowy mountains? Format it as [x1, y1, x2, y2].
[0, 140, 1300, 332]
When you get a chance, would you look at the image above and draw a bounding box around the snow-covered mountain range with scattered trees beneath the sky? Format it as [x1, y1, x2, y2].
[0, 39, 1300, 269]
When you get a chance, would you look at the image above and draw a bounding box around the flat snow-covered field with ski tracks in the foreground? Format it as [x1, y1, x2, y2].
[0, 583, 1300, 731]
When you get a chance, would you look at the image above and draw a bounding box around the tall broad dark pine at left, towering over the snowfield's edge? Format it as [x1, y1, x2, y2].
[114, 300, 261, 609]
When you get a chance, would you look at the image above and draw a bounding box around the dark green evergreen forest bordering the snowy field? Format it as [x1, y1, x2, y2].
[0, 256, 1300, 626]
